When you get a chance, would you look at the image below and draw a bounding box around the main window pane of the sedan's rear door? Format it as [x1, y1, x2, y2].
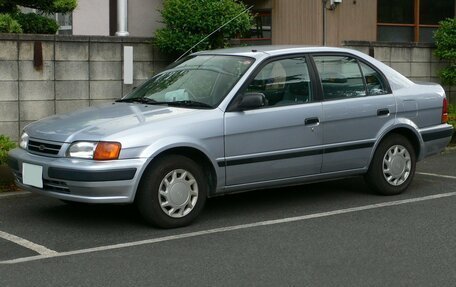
[314, 56, 366, 100]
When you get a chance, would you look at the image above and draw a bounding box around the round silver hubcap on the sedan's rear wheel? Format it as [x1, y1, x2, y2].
[383, 145, 412, 186]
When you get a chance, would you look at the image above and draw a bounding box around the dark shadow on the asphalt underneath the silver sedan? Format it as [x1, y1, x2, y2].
[29, 177, 370, 230]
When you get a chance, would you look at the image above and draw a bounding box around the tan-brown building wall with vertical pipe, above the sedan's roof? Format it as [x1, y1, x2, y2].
[272, 0, 377, 46]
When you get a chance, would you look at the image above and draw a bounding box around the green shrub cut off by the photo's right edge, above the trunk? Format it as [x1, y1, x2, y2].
[434, 18, 456, 86]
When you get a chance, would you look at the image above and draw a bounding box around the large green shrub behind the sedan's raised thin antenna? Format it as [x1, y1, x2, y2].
[155, 0, 252, 55]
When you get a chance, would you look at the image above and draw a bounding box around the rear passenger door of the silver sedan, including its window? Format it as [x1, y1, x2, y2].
[313, 54, 396, 173]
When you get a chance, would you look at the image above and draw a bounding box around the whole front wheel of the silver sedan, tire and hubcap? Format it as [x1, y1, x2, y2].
[136, 155, 208, 228]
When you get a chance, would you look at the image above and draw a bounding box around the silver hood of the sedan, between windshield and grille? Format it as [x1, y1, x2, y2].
[25, 103, 199, 142]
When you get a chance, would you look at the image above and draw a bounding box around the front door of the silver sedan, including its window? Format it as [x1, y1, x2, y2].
[223, 56, 322, 185]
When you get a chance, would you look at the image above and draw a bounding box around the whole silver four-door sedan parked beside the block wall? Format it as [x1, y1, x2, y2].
[9, 46, 453, 228]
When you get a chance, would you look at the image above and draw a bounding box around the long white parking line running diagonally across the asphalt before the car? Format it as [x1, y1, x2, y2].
[0, 192, 456, 264]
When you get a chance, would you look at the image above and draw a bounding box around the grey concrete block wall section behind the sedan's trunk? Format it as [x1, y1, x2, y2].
[344, 41, 456, 104]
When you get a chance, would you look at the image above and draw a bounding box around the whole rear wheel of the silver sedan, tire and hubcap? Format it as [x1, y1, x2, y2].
[365, 134, 416, 195]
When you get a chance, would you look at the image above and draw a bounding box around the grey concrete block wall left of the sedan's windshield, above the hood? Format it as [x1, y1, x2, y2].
[0, 34, 170, 140]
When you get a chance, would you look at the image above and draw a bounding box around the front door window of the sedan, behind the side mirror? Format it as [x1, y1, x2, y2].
[246, 57, 312, 107]
